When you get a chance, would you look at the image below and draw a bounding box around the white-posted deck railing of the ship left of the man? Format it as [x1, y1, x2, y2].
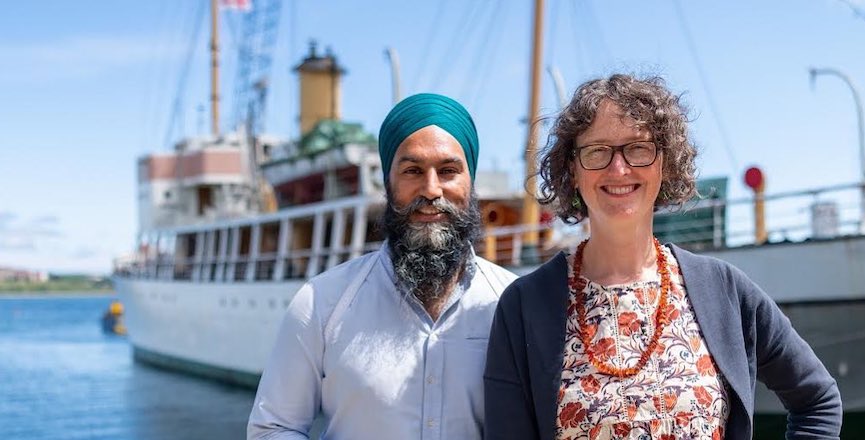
[115, 195, 382, 282]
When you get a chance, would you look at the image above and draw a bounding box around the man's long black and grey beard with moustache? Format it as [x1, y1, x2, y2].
[382, 188, 481, 304]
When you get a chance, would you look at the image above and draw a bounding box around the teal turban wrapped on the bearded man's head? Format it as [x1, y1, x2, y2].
[378, 93, 478, 183]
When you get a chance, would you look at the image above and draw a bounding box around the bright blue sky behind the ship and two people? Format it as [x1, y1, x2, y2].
[0, 0, 865, 273]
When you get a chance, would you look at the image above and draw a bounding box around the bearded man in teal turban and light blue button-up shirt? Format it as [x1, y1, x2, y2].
[248, 93, 515, 440]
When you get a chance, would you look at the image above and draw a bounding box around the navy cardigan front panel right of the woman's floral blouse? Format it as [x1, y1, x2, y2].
[668, 245, 753, 419]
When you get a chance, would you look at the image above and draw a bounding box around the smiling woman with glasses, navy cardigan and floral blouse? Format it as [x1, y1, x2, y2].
[484, 75, 841, 440]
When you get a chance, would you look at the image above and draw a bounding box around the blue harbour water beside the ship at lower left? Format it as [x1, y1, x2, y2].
[0, 294, 254, 440]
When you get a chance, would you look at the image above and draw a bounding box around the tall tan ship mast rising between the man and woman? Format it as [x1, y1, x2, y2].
[521, 0, 544, 262]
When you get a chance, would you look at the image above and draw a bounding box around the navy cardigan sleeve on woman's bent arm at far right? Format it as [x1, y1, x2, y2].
[740, 274, 842, 439]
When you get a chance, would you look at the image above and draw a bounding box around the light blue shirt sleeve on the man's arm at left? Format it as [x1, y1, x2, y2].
[247, 283, 324, 440]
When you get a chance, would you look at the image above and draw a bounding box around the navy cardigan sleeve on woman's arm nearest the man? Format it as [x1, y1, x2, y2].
[484, 284, 538, 440]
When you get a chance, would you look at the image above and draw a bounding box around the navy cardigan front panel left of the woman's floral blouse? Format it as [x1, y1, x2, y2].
[525, 252, 568, 439]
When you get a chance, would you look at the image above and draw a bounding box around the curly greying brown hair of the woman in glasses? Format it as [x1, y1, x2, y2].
[537, 74, 697, 224]
